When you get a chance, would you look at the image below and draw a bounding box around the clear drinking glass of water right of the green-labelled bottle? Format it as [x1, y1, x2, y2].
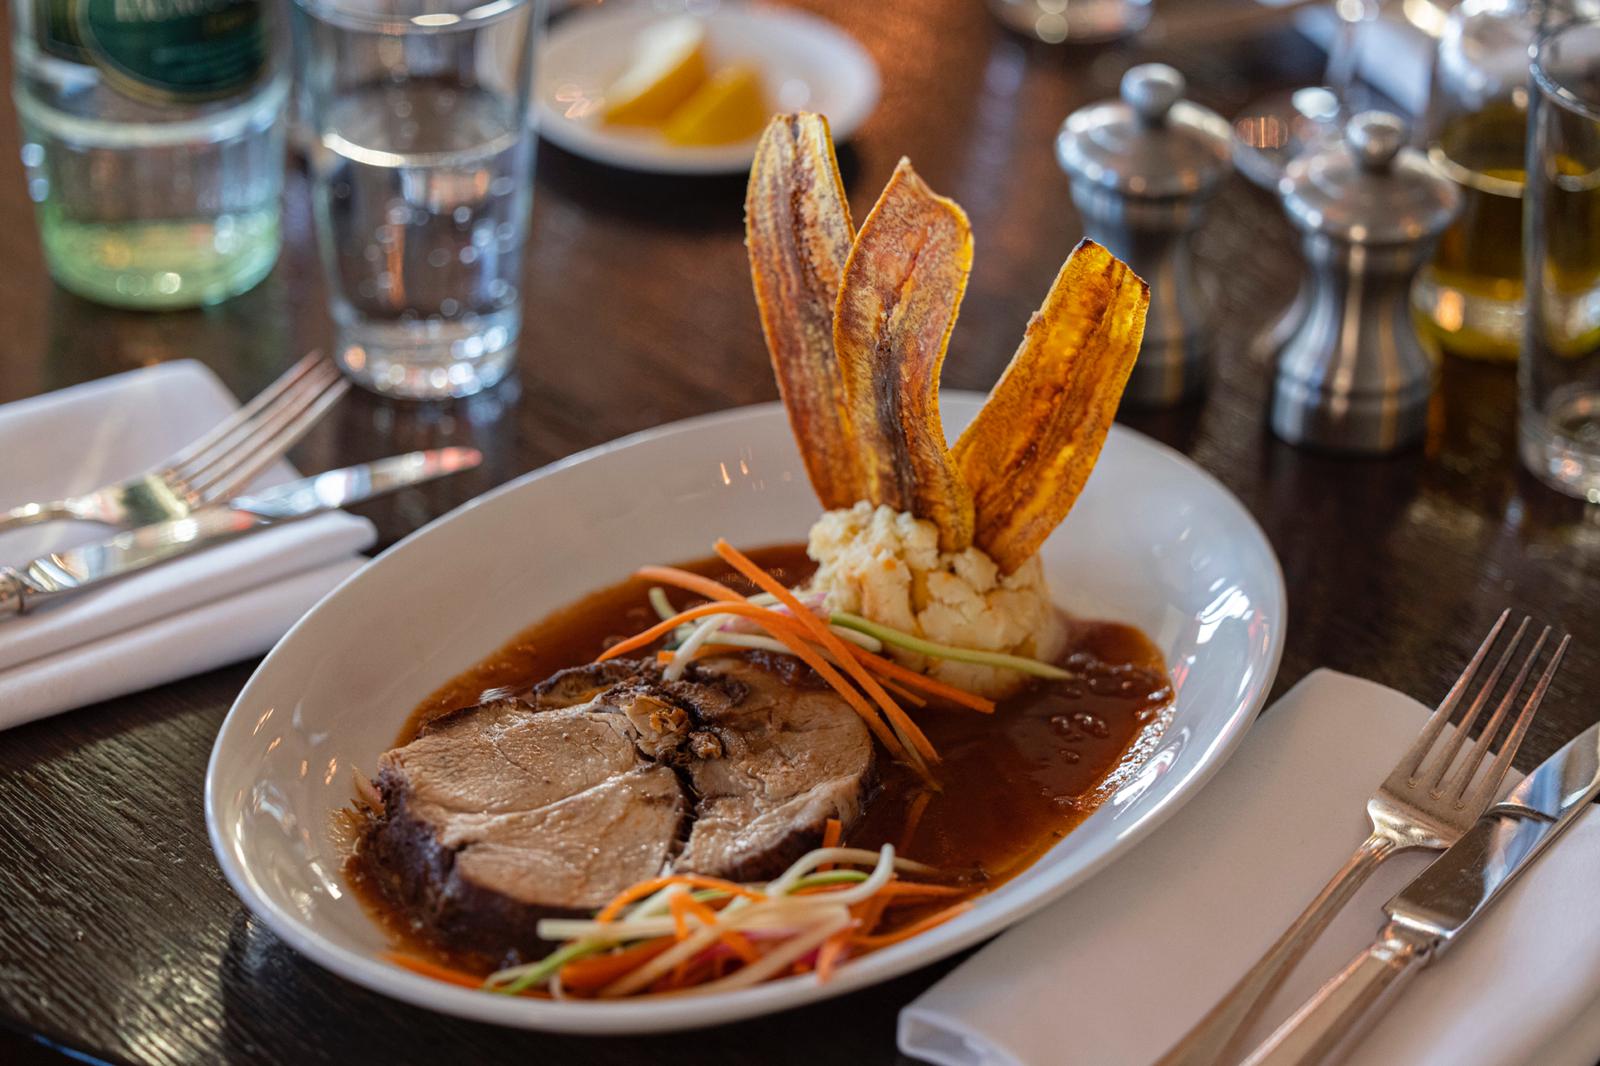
[294, 0, 542, 399]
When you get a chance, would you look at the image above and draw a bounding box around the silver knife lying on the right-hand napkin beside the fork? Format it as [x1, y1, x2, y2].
[1245, 713, 1600, 1066]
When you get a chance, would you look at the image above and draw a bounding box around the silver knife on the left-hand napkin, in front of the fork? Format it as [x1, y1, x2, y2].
[0, 448, 483, 618]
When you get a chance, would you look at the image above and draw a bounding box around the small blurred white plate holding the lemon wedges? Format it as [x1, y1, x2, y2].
[534, 5, 878, 174]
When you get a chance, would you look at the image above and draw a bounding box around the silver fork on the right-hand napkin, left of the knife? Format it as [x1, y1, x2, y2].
[1158, 610, 1566, 1066]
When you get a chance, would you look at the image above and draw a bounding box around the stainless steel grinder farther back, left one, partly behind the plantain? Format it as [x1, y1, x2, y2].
[1056, 62, 1232, 407]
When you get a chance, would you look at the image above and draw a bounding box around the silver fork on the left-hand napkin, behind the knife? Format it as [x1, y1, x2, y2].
[0, 352, 350, 533]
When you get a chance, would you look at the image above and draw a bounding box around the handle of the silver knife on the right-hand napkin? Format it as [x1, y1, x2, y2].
[1242, 922, 1434, 1066]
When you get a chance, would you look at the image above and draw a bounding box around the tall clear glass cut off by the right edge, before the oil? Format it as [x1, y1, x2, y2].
[1518, 19, 1600, 503]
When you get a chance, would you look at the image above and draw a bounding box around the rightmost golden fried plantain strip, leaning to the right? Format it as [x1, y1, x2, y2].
[955, 240, 1150, 573]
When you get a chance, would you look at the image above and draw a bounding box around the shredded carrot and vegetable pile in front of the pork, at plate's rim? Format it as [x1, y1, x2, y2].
[467, 845, 971, 999]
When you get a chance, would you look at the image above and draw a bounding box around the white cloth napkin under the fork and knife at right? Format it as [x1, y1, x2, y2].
[899, 671, 1600, 1066]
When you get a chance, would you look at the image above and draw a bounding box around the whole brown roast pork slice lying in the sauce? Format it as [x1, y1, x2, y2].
[368, 658, 872, 957]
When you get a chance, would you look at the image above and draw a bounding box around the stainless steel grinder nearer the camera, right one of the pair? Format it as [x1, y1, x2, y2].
[1272, 110, 1461, 455]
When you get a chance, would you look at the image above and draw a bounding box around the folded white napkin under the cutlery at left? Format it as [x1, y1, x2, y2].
[0, 360, 376, 728]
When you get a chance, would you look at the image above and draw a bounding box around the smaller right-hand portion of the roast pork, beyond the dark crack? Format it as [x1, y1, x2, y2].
[674, 659, 874, 880]
